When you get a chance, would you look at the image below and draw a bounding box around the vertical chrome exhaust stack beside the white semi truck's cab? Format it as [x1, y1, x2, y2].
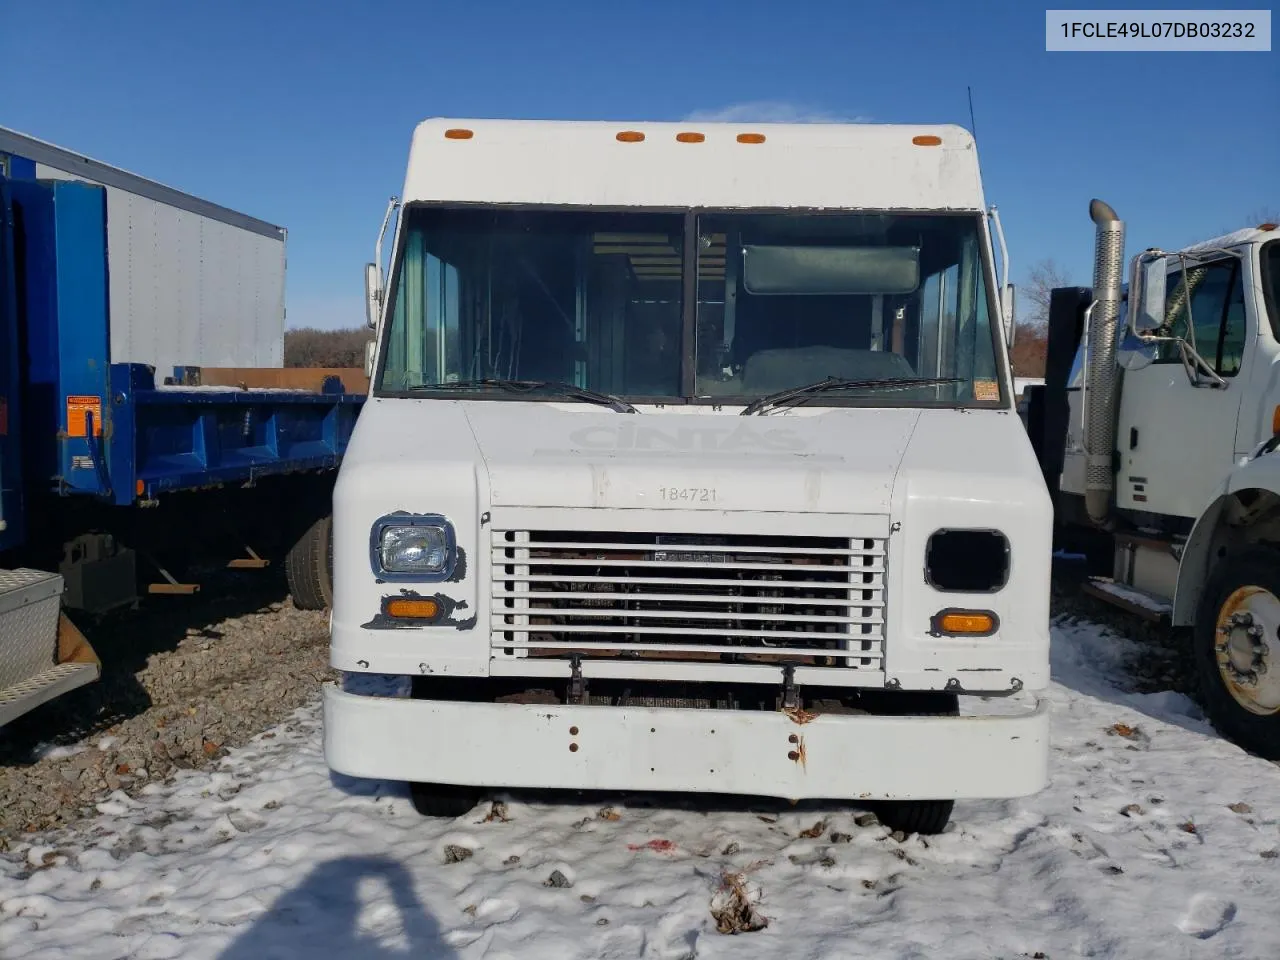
[1084, 200, 1124, 524]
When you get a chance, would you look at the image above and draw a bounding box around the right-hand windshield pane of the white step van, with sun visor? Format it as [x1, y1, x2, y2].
[696, 214, 1000, 406]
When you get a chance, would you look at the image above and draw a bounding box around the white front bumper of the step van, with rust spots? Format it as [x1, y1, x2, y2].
[324, 685, 1048, 800]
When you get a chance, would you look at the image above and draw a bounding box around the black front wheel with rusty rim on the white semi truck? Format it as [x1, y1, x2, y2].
[1192, 547, 1280, 760]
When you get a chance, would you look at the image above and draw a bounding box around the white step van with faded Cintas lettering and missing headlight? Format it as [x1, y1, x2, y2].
[325, 120, 1052, 832]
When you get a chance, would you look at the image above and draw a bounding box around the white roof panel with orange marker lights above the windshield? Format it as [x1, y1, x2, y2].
[402, 119, 983, 210]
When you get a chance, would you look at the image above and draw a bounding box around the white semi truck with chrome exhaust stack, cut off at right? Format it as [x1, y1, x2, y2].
[1028, 200, 1280, 759]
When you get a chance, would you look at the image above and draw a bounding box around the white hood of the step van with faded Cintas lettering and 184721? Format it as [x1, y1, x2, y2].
[451, 402, 920, 515]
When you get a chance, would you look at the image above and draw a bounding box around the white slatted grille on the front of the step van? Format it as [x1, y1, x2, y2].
[492, 530, 884, 669]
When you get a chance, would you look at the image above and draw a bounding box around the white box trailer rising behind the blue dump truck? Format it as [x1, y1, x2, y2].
[0, 120, 285, 381]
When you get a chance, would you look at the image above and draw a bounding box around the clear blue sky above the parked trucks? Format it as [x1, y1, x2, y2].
[0, 0, 1280, 326]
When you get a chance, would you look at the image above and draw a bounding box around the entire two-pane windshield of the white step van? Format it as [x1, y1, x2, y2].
[378, 206, 1001, 406]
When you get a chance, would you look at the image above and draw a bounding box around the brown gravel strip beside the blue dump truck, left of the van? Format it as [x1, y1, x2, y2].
[0, 602, 337, 850]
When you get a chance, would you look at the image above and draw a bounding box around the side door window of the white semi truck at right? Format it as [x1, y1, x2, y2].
[1156, 257, 1245, 376]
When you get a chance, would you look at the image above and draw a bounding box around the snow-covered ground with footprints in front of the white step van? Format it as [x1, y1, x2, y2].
[0, 621, 1280, 960]
